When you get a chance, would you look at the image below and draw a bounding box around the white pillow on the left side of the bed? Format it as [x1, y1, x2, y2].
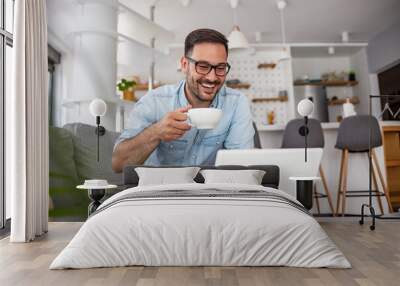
[135, 167, 200, 186]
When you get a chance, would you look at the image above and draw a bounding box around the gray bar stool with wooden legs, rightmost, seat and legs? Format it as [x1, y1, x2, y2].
[335, 115, 393, 216]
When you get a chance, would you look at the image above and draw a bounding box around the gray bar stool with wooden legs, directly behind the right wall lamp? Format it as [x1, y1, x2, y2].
[282, 118, 335, 214]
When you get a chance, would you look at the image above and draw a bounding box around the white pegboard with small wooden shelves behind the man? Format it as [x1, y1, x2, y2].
[228, 50, 292, 125]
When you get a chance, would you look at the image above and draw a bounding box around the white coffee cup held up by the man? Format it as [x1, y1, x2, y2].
[187, 108, 222, 129]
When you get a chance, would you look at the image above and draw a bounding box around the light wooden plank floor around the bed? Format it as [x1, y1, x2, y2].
[0, 218, 400, 286]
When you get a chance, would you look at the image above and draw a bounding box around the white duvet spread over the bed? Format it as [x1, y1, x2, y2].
[50, 184, 351, 269]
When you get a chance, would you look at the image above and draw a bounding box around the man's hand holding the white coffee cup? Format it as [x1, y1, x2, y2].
[154, 105, 192, 142]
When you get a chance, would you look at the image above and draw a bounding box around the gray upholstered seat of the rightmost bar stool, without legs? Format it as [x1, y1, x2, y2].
[335, 115, 382, 152]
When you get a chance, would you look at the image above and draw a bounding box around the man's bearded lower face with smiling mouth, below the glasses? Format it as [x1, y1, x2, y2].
[186, 75, 224, 102]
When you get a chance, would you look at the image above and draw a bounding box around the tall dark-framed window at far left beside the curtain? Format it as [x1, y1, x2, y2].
[0, 0, 14, 229]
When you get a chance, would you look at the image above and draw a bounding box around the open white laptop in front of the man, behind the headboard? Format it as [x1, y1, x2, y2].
[215, 148, 323, 196]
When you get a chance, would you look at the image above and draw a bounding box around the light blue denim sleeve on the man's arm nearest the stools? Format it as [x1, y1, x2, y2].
[224, 95, 255, 149]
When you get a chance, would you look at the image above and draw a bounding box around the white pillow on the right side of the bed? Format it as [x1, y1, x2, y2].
[200, 170, 265, 185]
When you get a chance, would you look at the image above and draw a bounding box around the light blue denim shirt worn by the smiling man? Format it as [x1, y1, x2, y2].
[114, 80, 254, 166]
